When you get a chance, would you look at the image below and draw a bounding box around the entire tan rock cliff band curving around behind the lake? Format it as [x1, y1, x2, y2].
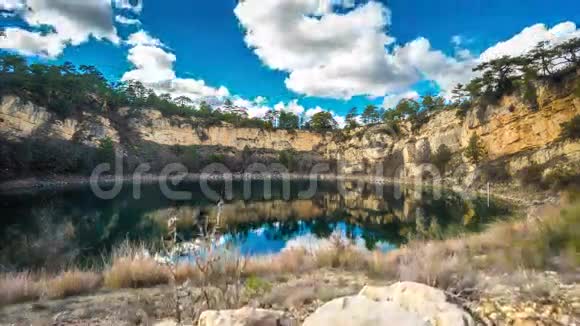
[0, 75, 580, 183]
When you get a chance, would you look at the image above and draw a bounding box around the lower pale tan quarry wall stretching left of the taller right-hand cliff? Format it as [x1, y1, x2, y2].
[0, 96, 325, 152]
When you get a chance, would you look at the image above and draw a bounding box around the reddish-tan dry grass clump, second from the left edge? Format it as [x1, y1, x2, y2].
[46, 270, 102, 299]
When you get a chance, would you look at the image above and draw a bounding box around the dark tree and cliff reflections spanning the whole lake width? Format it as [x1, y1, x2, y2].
[0, 183, 507, 268]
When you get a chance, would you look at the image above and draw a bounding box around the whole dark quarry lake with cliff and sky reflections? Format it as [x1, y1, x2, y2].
[0, 181, 510, 271]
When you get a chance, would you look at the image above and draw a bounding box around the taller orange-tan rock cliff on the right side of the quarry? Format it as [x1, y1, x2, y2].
[321, 77, 580, 183]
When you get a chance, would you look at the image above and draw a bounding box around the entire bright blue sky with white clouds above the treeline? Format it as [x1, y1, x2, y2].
[0, 0, 580, 120]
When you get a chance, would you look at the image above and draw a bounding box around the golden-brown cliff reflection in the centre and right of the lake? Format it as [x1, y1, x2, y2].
[153, 185, 506, 249]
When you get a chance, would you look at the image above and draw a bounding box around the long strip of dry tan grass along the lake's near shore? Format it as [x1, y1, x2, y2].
[0, 198, 580, 305]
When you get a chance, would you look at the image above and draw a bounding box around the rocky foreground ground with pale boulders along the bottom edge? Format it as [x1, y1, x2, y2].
[0, 270, 580, 326]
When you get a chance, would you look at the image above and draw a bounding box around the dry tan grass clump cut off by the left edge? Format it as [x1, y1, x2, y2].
[0, 273, 42, 305]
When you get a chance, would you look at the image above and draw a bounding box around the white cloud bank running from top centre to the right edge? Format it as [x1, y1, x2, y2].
[234, 0, 580, 104]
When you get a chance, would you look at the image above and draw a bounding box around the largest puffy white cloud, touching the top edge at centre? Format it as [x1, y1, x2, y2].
[235, 0, 419, 99]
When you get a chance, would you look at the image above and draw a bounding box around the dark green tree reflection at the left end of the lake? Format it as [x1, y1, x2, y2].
[0, 192, 161, 272]
